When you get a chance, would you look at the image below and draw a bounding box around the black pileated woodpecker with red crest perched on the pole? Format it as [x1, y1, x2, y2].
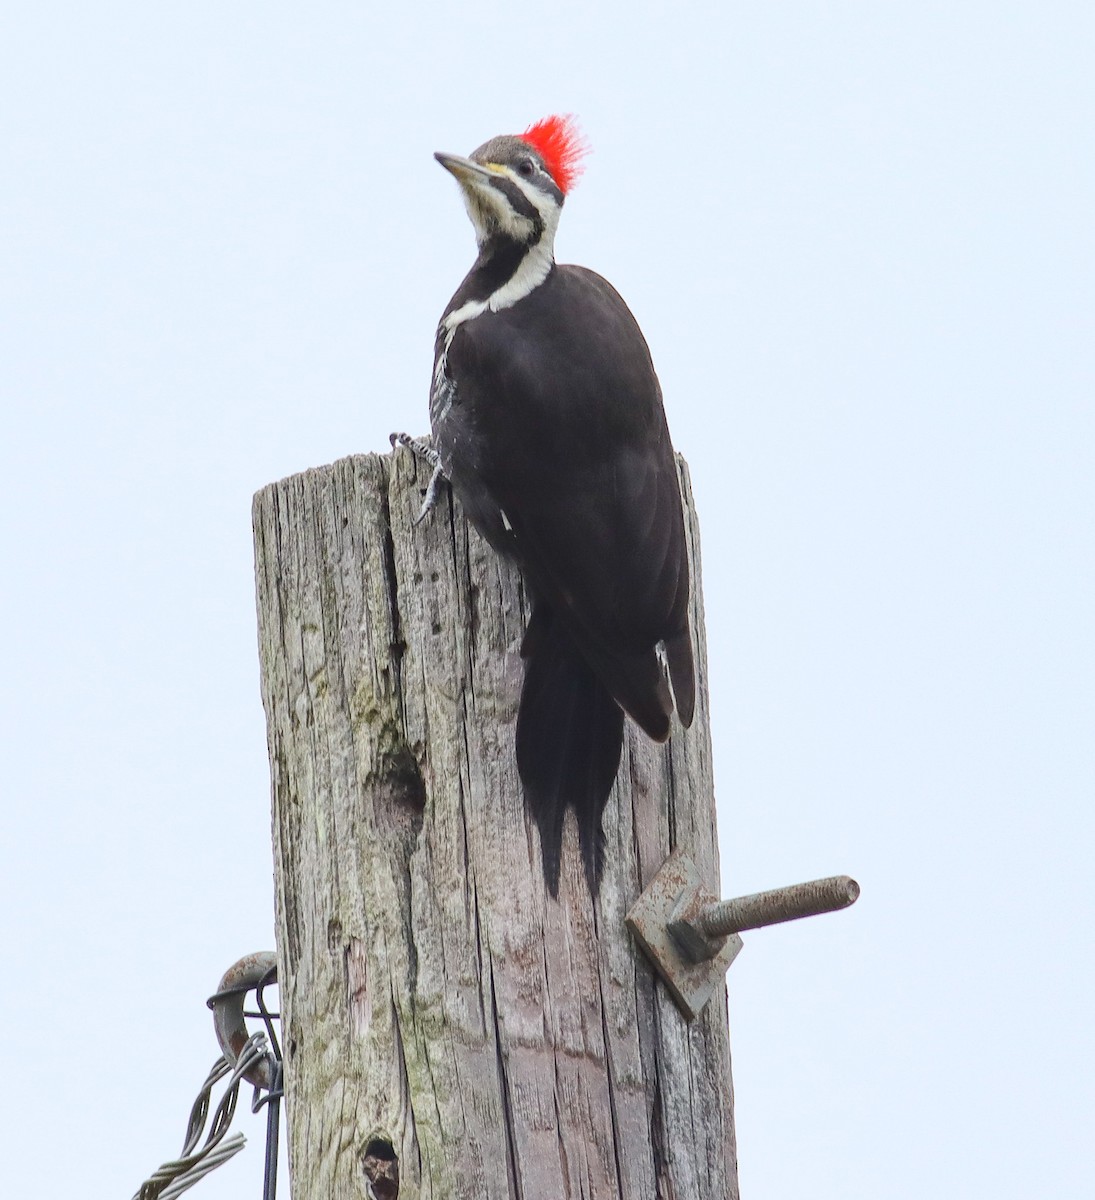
[406, 116, 695, 895]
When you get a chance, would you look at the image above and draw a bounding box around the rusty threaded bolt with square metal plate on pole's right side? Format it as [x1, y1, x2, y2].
[627, 850, 860, 1021]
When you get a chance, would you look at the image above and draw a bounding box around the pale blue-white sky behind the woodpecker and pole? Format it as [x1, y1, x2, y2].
[0, 0, 1095, 1200]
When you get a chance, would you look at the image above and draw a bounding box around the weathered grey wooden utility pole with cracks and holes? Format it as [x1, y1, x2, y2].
[255, 451, 737, 1200]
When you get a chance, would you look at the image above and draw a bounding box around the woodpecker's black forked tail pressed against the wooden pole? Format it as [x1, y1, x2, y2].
[517, 604, 623, 896]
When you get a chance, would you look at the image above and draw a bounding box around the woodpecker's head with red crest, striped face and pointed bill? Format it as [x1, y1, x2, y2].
[433, 116, 588, 247]
